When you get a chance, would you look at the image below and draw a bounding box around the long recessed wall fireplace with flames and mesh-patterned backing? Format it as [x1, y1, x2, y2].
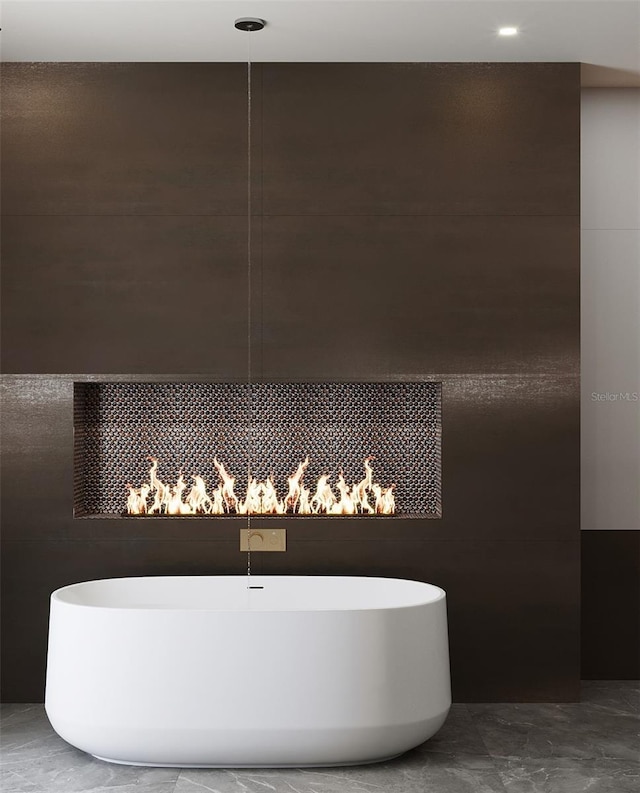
[74, 382, 442, 518]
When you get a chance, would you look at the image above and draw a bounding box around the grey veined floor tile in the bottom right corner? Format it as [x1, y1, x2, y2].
[496, 757, 640, 793]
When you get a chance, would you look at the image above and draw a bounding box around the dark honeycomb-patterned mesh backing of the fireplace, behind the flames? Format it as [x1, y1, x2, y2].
[74, 382, 441, 518]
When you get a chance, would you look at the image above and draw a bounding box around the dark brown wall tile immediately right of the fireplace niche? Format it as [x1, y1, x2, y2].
[441, 375, 580, 541]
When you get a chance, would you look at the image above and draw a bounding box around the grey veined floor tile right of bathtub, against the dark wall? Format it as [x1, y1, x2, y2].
[468, 703, 640, 763]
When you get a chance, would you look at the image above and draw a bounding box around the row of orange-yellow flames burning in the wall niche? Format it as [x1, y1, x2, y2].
[126, 457, 396, 515]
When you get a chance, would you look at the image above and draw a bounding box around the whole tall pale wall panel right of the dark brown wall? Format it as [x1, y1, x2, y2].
[582, 89, 640, 529]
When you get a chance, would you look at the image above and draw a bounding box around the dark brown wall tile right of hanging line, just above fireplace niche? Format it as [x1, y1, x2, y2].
[263, 217, 580, 379]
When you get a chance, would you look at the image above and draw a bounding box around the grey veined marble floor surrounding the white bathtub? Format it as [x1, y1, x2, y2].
[0, 681, 640, 793]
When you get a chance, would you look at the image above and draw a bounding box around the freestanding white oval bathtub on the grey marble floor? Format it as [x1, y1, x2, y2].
[45, 576, 451, 767]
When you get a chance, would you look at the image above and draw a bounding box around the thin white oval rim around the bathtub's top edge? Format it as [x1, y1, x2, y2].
[50, 574, 447, 614]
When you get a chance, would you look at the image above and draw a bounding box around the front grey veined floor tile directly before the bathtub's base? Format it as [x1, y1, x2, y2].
[175, 752, 505, 793]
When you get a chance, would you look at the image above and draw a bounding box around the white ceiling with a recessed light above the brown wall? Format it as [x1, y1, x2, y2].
[0, 0, 640, 86]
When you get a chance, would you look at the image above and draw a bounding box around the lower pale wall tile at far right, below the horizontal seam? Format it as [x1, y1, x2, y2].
[582, 230, 640, 529]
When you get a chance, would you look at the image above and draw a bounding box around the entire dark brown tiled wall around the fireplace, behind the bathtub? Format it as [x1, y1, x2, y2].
[2, 64, 580, 701]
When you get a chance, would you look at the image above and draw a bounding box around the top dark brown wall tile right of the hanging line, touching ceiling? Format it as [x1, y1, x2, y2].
[263, 63, 580, 215]
